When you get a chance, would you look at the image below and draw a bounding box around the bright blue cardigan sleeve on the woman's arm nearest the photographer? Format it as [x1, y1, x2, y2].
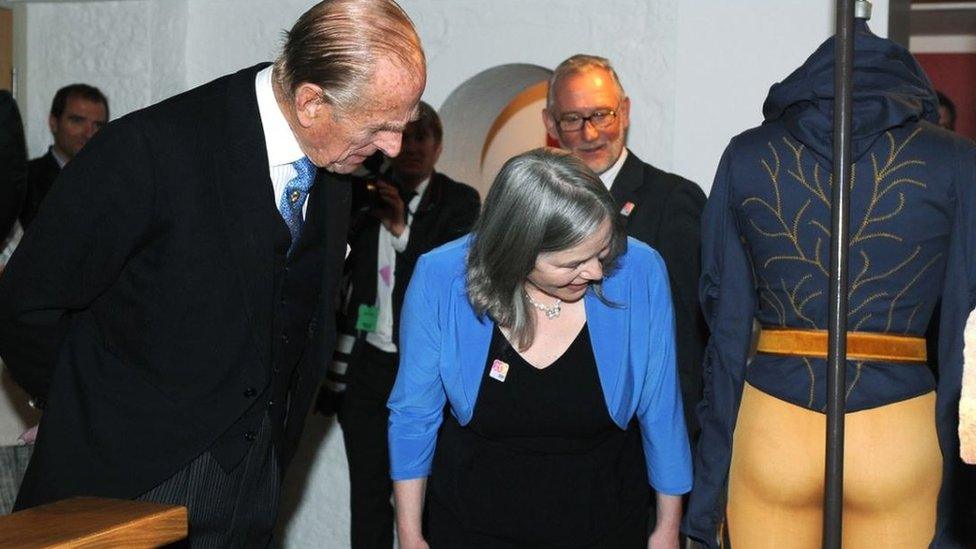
[388, 256, 447, 480]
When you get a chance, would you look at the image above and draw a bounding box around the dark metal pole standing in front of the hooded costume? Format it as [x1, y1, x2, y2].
[823, 0, 854, 549]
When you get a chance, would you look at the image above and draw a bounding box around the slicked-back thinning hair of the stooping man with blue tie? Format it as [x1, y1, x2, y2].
[274, 0, 426, 112]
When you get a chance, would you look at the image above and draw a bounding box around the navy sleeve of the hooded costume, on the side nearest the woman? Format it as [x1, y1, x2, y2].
[683, 140, 756, 547]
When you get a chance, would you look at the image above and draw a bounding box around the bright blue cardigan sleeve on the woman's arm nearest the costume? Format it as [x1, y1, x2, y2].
[631, 246, 692, 495]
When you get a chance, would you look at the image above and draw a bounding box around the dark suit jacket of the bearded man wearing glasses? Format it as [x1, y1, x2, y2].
[610, 150, 707, 441]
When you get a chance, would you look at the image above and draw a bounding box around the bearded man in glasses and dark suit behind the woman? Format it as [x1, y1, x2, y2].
[542, 55, 707, 441]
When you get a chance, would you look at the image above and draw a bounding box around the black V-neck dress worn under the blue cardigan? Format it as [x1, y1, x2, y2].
[426, 325, 650, 549]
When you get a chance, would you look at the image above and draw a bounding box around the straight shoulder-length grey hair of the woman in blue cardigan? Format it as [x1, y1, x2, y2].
[467, 148, 627, 349]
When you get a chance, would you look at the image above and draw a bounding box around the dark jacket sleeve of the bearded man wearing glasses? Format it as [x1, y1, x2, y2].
[657, 180, 708, 439]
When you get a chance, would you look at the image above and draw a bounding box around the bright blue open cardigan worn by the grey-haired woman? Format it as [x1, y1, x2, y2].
[389, 233, 692, 495]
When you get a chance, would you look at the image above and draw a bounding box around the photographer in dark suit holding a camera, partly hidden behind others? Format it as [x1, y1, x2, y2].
[322, 102, 480, 549]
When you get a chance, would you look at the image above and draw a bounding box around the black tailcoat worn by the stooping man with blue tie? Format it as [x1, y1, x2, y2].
[0, 65, 349, 508]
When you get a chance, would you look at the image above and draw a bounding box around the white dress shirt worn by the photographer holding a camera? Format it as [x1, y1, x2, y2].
[366, 178, 430, 353]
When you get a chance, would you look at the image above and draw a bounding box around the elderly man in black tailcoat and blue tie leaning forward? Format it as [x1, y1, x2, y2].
[0, 0, 426, 547]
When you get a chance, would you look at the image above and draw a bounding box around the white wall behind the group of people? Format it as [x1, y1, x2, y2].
[0, 0, 887, 547]
